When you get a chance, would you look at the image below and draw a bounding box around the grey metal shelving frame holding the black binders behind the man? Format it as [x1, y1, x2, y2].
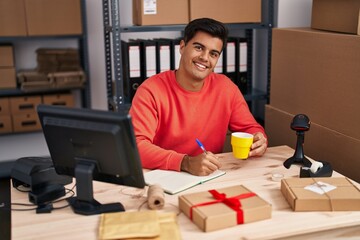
[103, 0, 274, 114]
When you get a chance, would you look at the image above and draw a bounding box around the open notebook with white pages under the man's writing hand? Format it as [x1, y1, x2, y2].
[144, 169, 225, 194]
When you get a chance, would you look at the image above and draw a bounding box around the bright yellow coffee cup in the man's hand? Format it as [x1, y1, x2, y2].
[231, 132, 254, 159]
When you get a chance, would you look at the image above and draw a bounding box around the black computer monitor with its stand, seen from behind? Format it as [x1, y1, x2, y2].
[37, 105, 145, 215]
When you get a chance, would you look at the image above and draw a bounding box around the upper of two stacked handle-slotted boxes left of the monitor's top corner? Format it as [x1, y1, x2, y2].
[10, 96, 41, 115]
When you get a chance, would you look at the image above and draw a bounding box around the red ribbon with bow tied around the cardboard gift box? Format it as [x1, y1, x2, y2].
[190, 190, 256, 224]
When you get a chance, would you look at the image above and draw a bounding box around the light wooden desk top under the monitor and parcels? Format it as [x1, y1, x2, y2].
[12, 146, 360, 240]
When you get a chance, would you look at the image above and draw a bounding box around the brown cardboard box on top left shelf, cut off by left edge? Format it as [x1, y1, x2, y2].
[0, 0, 27, 37]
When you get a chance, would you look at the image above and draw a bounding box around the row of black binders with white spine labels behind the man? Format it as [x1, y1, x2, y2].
[122, 37, 249, 103]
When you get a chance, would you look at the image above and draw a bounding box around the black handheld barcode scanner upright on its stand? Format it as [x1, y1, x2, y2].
[284, 114, 311, 168]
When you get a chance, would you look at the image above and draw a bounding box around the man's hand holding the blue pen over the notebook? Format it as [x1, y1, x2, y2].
[181, 152, 221, 176]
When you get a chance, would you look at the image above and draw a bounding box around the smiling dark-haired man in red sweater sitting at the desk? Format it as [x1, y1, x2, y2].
[130, 18, 267, 175]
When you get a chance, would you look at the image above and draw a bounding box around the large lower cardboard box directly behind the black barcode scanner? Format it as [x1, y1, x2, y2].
[265, 105, 360, 182]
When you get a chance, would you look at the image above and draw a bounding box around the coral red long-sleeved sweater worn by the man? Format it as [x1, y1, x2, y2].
[130, 71, 265, 171]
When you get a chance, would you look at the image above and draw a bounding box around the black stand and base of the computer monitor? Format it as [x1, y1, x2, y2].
[67, 161, 125, 215]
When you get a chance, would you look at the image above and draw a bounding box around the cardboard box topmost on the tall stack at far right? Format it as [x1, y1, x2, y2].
[311, 0, 360, 35]
